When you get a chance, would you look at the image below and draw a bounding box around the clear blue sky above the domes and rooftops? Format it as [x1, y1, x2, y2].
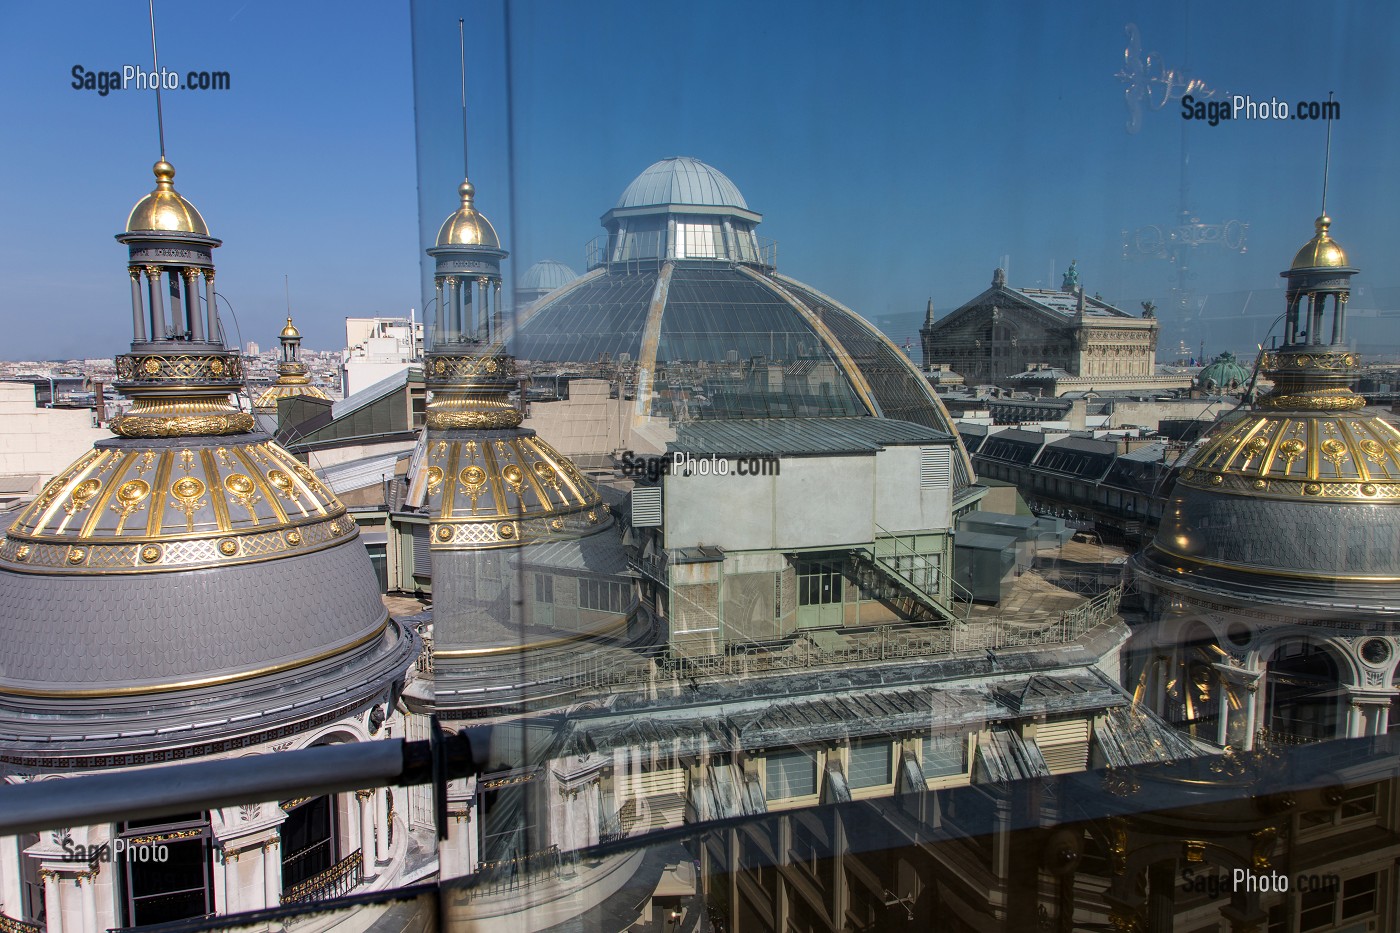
[0, 0, 1400, 359]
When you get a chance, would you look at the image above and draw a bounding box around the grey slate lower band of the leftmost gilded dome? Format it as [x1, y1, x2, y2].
[0, 538, 385, 691]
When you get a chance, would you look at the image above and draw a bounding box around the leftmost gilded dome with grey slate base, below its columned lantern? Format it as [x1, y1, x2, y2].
[0, 434, 398, 696]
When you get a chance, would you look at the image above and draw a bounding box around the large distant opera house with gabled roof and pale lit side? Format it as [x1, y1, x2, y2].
[920, 265, 1190, 395]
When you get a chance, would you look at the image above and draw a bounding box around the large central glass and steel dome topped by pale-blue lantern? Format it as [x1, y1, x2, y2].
[510, 160, 972, 485]
